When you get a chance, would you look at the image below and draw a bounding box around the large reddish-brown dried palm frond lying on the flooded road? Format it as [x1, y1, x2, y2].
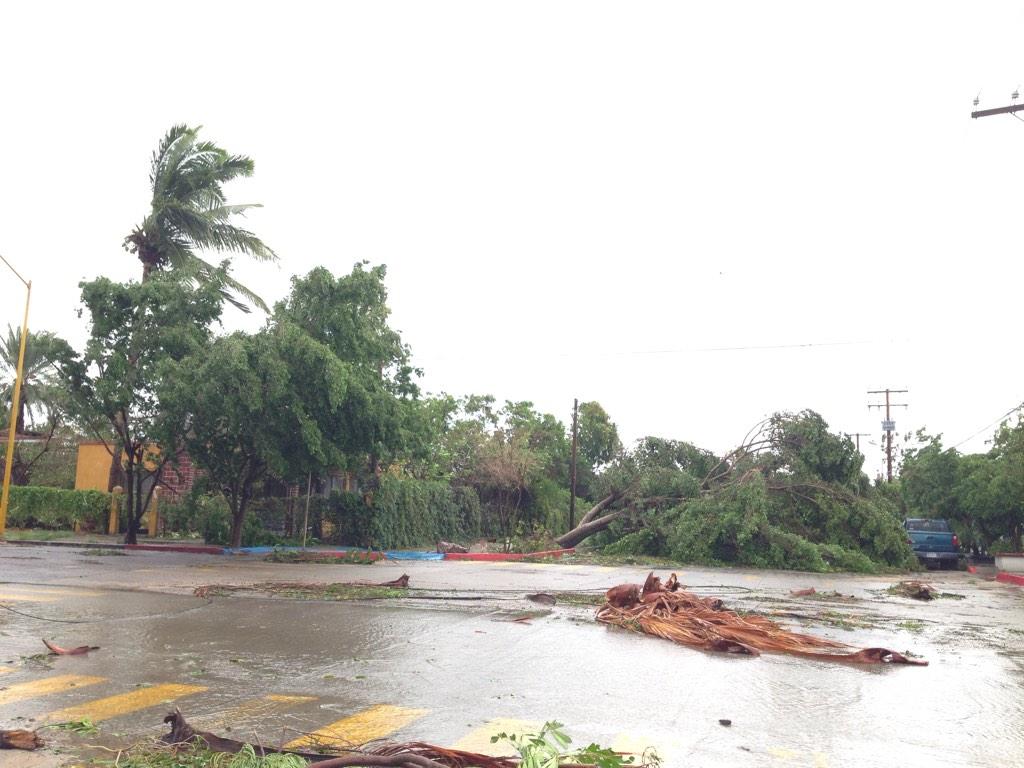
[597, 573, 928, 666]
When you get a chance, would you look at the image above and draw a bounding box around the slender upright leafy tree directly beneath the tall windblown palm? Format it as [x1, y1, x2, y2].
[60, 274, 222, 544]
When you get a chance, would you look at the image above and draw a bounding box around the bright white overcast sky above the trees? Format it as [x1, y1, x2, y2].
[0, 0, 1024, 474]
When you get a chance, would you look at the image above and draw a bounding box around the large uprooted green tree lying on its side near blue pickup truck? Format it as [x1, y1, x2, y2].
[557, 411, 912, 570]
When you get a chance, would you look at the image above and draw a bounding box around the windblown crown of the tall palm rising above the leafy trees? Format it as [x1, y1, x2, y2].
[124, 125, 278, 312]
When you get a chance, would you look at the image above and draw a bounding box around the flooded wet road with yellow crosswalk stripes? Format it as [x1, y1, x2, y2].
[0, 545, 1024, 767]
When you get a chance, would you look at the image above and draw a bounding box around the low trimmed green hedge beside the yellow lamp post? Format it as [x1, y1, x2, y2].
[7, 485, 111, 530]
